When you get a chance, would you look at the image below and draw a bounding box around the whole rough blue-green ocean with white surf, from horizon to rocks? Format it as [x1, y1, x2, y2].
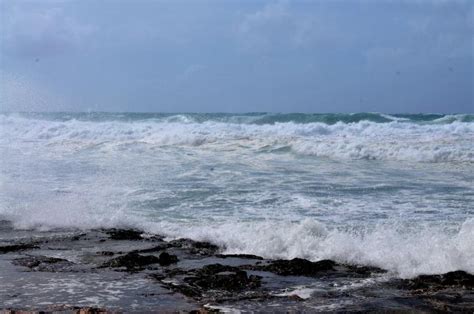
[0, 112, 474, 278]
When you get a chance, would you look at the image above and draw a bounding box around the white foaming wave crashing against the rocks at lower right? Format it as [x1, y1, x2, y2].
[149, 219, 474, 278]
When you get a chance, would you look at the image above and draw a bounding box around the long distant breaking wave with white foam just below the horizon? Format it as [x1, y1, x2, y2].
[0, 114, 474, 162]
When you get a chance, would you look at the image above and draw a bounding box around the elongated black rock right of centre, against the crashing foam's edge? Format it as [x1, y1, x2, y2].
[250, 258, 337, 277]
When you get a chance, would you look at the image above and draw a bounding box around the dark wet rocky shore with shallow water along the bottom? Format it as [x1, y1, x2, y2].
[0, 221, 474, 313]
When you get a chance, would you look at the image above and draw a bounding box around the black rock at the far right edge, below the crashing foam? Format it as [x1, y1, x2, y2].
[402, 270, 474, 290]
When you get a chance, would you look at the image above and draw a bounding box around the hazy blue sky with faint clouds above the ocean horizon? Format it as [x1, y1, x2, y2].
[0, 0, 474, 113]
